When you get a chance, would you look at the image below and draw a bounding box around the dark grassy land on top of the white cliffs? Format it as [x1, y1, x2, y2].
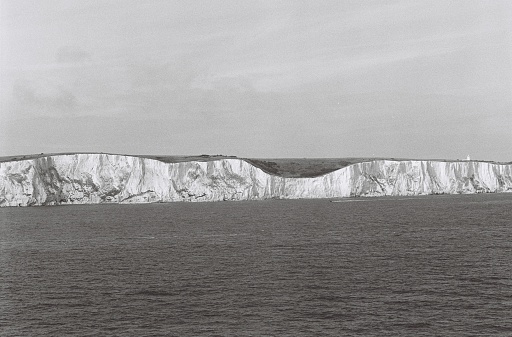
[0, 152, 512, 178]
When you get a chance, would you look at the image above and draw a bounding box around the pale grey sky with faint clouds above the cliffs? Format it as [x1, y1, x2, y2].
[0, 0, 512, 161]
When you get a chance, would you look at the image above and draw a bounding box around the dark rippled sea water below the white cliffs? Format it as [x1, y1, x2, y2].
[0, 194, 512, 336]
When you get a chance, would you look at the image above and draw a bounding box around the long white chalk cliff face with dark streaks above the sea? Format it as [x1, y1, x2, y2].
[0, 154, 512, 206]
